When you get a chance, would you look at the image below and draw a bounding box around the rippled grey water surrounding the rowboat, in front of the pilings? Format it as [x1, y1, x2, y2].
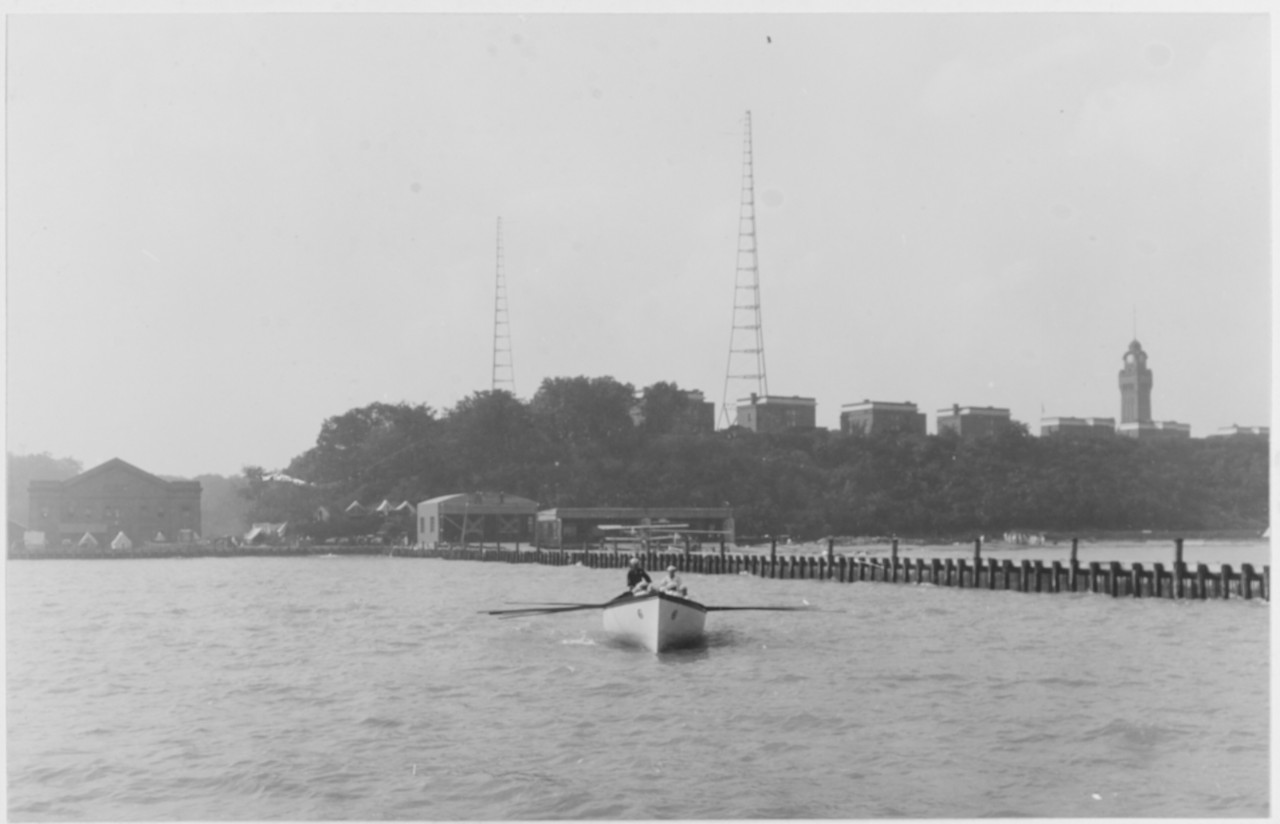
[6, 547, 1270, 821]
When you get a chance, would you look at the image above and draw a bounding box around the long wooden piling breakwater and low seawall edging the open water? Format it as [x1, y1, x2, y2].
[9, 539, 1271, 601]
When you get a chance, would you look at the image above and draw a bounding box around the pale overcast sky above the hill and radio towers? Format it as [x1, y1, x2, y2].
[6, 6, 1271, 476]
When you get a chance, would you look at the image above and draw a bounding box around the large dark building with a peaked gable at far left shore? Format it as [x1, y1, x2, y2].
[28, 458, 201, 548]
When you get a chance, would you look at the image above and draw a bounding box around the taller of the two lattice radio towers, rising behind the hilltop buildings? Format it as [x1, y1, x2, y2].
[721, 111, 769, 426]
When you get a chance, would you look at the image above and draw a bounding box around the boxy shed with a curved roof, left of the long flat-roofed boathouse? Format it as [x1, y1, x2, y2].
[417, 493, 538, 549]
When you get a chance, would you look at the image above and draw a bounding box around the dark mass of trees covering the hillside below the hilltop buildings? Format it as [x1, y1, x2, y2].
[242, 377, 1268, 540]
